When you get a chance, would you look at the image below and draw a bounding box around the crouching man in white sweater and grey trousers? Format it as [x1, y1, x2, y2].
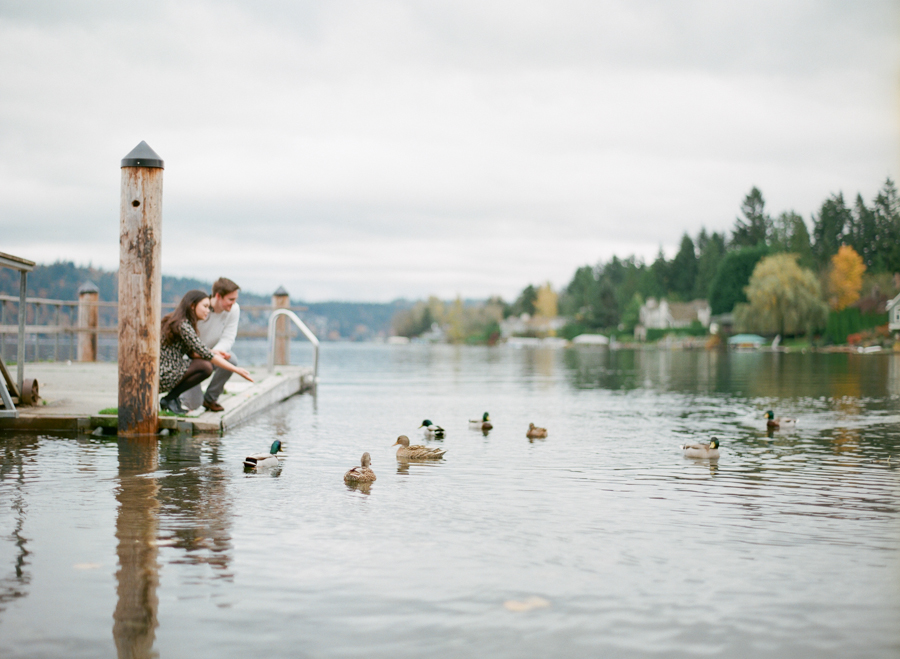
[181, 277, 241, 412]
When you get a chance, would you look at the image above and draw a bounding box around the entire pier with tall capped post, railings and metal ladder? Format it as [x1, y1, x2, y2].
[0, 142, 319, 441]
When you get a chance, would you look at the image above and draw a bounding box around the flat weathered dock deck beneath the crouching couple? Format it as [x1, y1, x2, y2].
[0, 362, 315, 434]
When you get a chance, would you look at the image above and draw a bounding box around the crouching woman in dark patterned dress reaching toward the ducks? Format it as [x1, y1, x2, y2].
[159, 290, 253, 414]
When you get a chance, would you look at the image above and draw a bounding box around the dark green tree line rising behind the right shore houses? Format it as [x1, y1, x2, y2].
[507, 178, 900, 333]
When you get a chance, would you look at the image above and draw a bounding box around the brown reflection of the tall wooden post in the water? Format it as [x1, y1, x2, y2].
[113, 439, 159, 658]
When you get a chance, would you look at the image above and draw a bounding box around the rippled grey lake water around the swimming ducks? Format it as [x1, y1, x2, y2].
[0, 344, 900, 658]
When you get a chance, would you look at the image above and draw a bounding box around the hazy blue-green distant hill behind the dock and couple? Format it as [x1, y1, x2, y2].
[0, 261, 412, 341]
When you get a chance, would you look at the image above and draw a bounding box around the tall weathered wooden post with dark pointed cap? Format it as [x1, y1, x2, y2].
[119, 142, 163, 437]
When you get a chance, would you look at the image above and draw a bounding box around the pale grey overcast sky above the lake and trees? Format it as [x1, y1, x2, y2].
[0, 0, 900, 301]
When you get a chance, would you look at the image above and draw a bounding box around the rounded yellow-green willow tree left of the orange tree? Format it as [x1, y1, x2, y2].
[734, 254, 828, 336]
